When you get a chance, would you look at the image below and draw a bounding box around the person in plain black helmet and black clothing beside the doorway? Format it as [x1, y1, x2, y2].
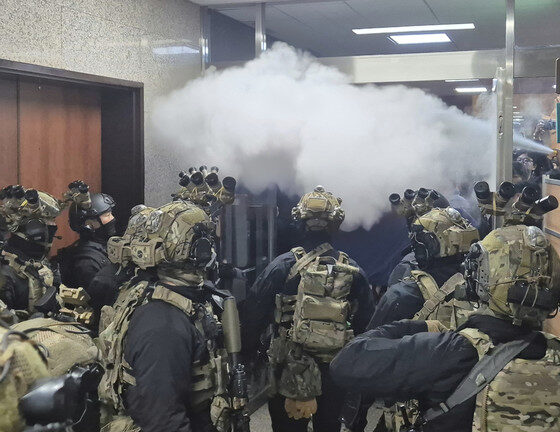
[56, 183, 118, 313]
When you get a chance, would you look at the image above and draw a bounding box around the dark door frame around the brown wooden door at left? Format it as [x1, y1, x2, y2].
[0, 59, 145, 233]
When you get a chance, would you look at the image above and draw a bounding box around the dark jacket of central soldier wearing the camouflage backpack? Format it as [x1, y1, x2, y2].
[242, 238, 377, 353]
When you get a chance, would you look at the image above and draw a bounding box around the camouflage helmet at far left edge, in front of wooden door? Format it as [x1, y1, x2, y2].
[0, 185, 63, 247]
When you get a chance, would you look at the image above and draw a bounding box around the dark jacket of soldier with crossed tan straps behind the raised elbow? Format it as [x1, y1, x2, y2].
[367, 254, 460, 330]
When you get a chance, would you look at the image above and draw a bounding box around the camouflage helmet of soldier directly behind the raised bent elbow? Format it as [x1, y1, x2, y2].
[410, 207, 479, 267]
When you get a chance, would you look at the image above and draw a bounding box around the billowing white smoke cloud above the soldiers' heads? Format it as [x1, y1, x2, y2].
[151, 43, 532, 229]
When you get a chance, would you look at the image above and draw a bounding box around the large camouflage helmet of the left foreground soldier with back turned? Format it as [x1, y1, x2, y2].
[107, 200, 215, 270]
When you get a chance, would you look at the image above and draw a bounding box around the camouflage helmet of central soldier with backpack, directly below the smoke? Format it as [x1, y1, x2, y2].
[292, 186, 344, 231]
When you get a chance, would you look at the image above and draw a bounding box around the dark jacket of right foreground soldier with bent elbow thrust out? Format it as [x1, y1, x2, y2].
[330, 315, 546, 432]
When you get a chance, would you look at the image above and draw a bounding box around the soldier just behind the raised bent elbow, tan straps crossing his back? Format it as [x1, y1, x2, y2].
[368, 203, 478, 329]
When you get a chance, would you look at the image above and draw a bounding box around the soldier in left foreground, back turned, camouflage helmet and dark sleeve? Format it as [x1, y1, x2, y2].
[100, 172, 248, 432]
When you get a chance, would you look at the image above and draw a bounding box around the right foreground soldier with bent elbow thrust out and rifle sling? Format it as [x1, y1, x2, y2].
[331, 206, 560, 432]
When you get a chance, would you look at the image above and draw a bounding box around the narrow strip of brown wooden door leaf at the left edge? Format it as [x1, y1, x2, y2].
[0, 78, 18, 188]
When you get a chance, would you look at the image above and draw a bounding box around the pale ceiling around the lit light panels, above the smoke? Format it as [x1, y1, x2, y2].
[208, 0, 560, 57]
